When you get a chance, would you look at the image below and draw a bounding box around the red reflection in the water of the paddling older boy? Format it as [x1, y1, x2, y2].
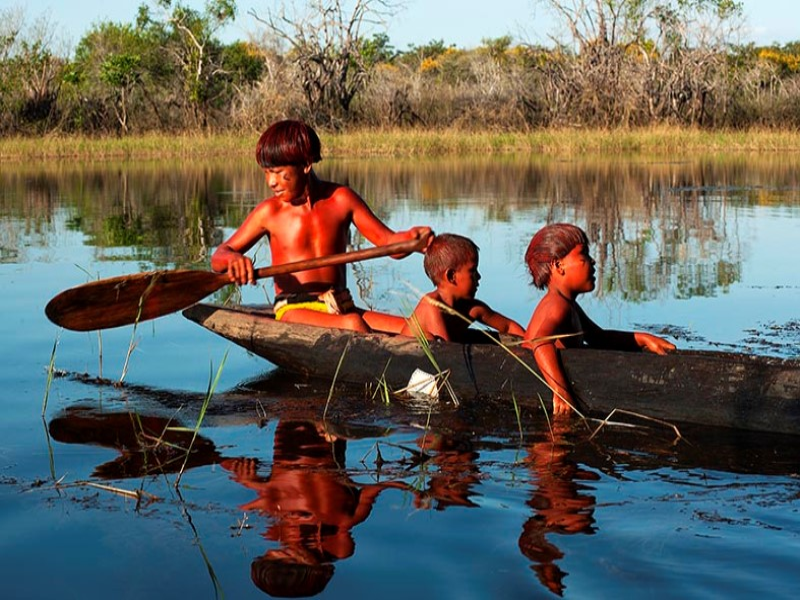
[221, 421, 408, 597]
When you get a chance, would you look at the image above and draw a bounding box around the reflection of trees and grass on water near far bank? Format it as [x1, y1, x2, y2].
[6, 155, 800, 301]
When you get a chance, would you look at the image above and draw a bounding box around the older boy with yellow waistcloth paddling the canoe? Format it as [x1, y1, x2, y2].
[211, 121, 431, 333]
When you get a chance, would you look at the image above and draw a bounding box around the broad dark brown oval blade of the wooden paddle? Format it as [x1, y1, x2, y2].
[45, 270, 229, 331]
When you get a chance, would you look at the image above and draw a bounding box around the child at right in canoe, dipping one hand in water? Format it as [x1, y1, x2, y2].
[525, 223, 675, 415]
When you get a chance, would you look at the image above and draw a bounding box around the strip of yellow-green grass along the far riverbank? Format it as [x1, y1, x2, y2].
[0, 127, 800, 162]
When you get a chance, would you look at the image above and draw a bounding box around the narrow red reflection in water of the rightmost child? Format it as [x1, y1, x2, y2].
[519, 420, 599, 596]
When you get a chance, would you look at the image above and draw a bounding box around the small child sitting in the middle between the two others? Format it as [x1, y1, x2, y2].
[400, 233, 524, 343]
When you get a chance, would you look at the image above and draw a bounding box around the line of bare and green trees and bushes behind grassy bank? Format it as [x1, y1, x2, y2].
[0, 0, 800, 136]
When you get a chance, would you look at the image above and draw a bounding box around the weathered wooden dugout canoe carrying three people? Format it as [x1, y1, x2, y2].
[183, 303, 800, 435]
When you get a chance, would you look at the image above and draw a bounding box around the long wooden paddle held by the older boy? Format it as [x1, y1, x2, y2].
[44, 240, 424, 331]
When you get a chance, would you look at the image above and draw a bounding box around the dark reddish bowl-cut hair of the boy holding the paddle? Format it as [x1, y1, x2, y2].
[256, 121, 322, 169]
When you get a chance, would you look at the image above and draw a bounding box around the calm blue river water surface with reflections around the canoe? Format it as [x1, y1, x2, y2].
[0, 155, 800, 599]
